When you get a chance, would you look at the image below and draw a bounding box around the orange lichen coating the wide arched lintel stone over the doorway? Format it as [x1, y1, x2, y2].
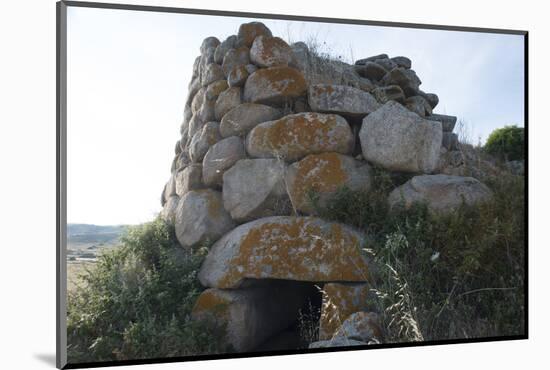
[218, 217, 368, 288]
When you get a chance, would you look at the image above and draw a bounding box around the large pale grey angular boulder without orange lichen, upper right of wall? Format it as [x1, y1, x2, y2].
[359, 101, 442, 173]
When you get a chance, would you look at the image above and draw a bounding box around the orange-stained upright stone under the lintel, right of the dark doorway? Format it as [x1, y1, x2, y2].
[319, 283, 374, 340]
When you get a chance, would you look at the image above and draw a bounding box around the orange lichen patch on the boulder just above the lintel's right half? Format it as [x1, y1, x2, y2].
[290, 152, 348, 204]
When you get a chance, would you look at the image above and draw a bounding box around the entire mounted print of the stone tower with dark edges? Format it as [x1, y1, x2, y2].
[57, 1, 528, 368]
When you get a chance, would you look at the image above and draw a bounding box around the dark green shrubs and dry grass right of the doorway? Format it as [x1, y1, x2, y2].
[310, 169, 526, 342]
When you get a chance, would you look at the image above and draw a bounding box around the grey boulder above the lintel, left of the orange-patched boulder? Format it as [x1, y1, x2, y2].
[223, 159, 291, 222]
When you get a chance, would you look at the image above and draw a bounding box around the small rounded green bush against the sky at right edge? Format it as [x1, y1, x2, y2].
[484, 125, 525, 161]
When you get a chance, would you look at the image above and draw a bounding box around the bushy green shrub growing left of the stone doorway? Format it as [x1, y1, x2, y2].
[67, 218, 227, 363]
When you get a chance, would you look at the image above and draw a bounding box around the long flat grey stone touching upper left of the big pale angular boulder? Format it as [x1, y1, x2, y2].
[308, 84, 380, 117]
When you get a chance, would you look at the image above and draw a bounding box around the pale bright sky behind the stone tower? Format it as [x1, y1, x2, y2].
[67, 7, 524, 225]
